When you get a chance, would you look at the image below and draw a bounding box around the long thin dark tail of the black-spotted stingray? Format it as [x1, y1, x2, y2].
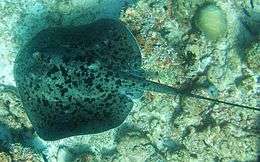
[120, 72, 260, 111]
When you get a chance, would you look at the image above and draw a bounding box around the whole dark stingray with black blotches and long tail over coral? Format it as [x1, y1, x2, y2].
[14, 19, 259, 140]
